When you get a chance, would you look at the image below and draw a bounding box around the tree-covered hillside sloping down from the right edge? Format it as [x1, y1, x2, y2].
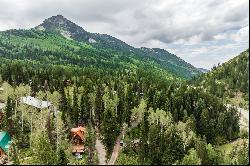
[191, 49, 249, 109]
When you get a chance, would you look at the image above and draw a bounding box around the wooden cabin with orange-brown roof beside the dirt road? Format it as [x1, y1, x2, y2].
[71, 126, 86, 158]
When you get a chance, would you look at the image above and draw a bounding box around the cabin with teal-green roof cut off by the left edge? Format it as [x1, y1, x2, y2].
[0, 131, 12, 160]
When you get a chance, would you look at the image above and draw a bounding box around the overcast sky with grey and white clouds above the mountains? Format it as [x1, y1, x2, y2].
[0, 0, 249, 69]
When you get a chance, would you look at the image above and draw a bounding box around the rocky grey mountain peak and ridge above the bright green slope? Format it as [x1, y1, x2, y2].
[35, 15, 201, 79]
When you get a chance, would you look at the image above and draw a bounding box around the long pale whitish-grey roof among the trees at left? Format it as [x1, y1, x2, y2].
[21, 96, 52, 109]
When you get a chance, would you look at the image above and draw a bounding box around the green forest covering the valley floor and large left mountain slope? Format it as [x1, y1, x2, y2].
[0, 14, 249, 165]
